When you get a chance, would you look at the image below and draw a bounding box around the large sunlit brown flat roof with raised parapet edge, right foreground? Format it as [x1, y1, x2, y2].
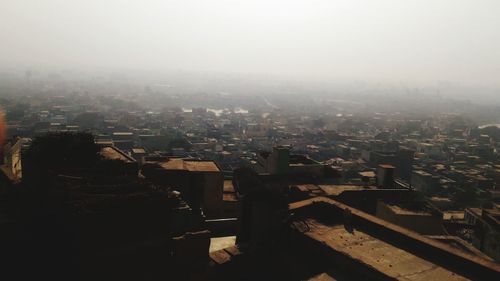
[289, 197, 500, 280]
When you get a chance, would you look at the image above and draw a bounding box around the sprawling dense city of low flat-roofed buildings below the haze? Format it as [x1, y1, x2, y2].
[0, 88, 500, 280]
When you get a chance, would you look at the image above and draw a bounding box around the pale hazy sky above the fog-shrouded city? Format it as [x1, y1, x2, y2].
[0, 0, 500, 86]
